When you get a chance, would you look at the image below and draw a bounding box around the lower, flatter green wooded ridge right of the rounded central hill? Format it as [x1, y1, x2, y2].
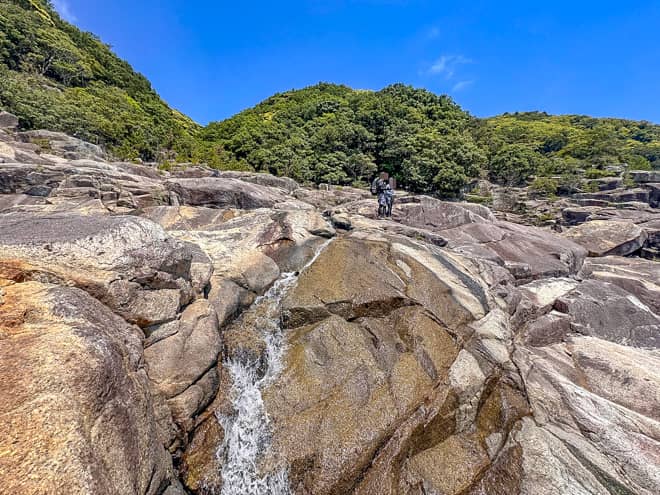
[475, 112, 660, 185]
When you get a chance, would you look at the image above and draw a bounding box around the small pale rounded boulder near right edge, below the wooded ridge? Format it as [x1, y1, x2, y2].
[564, 220, 647, 256]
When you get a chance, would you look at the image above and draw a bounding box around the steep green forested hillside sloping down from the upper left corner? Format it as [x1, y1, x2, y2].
[0, 0, 197, 160]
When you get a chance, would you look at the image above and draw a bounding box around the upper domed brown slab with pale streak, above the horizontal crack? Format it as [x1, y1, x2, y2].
[283, 234, 489, 334]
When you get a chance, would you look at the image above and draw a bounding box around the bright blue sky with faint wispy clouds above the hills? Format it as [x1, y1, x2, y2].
[53, 0, 660, 123]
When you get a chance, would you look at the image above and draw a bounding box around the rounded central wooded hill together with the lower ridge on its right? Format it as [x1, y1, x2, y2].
[201, 83, 660, 196]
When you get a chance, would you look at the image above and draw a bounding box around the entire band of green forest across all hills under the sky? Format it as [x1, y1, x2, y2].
[0, 0, 660, 197]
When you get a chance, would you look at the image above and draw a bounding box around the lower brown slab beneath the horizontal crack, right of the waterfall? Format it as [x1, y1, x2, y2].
[265, 308, 457, 494]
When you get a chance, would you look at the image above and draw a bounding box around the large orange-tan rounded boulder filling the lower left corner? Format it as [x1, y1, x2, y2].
[0, 280, 172, 495]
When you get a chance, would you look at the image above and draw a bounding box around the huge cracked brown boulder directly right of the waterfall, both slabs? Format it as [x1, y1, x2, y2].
[265, 235, 508, 494]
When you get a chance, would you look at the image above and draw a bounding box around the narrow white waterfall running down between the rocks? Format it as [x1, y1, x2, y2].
[216, 241, 330, 495]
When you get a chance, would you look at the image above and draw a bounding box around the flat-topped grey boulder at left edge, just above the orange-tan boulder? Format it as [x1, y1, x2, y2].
[0, 213, 193, 327]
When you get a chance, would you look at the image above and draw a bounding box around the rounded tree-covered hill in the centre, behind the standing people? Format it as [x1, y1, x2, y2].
[200, 83, 486, 196]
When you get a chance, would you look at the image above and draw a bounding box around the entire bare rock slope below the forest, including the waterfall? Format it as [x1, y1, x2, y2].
[0, 129, 660, 495]
